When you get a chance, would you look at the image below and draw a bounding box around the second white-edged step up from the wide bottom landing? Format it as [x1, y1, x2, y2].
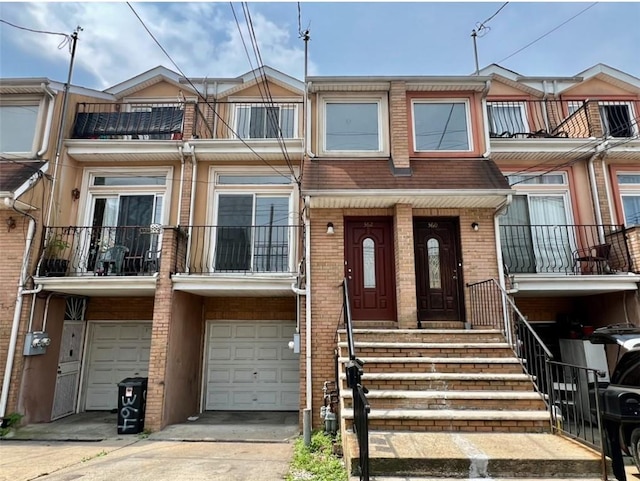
[340, 389, 546, 411]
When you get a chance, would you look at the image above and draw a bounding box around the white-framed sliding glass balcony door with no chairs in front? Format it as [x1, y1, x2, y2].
[213, 173, 295, 273]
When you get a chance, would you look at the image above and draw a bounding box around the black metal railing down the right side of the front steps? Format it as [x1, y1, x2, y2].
[467, 279, 607, 480]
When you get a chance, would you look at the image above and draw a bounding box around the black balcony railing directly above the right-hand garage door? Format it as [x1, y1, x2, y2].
[178, 225, 298, 274]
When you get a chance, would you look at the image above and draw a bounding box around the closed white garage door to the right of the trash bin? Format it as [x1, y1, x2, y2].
[205, 322, 300, 411]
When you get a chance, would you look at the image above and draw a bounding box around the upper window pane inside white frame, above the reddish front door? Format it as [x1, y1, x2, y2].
[324, 101, 382, 152]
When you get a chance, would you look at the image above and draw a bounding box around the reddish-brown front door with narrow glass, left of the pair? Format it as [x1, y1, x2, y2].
[345, 217, 396, 321]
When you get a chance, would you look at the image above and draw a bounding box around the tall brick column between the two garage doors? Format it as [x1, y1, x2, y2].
[145, 228, 178, 431]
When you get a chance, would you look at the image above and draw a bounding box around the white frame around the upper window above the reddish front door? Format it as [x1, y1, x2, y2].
[316, 92, 390, 157]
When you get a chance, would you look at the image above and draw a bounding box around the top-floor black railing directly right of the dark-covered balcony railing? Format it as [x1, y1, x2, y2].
[193, 101, 302, 140]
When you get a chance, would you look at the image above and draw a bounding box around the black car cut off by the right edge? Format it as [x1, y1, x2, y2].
[589, 325, 640, 474]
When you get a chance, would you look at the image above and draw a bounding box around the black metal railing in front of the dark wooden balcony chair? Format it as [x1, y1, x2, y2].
[500, 225, 634, 275]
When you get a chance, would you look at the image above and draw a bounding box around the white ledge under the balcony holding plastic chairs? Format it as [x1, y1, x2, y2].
[34, 275, 157, 297]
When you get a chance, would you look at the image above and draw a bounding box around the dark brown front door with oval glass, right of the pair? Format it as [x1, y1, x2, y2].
[413, 219, 463, 325]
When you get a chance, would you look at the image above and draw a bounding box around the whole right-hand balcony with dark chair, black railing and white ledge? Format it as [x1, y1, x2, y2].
[500, 225, 640, 295]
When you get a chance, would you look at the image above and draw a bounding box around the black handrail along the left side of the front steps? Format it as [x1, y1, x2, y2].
[342, 278, 371, 481]
